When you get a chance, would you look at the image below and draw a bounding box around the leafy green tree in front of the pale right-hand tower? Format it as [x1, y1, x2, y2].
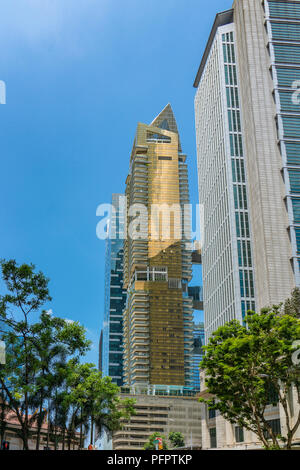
[200, 306, 300, 449]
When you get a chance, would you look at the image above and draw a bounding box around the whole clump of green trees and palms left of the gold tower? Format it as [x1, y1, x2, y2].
[0, 260, 134, 450]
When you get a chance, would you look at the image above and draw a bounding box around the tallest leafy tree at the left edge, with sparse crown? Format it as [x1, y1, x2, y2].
[0, 260, 90, 450]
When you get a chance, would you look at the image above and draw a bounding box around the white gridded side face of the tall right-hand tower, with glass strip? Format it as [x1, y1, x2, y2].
[195, 10, 255, 338]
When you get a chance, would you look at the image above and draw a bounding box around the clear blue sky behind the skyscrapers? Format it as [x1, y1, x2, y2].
[0, 0, 232, 363]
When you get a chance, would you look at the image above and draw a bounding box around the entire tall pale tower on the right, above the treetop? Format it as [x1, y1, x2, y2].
[194, 0, 300, 342]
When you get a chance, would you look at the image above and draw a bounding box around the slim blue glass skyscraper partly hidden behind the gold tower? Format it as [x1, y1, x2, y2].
[99, 194, 126, 386]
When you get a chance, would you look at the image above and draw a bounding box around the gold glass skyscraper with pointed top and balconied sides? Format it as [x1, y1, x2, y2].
[124, 105, 193, 389]
